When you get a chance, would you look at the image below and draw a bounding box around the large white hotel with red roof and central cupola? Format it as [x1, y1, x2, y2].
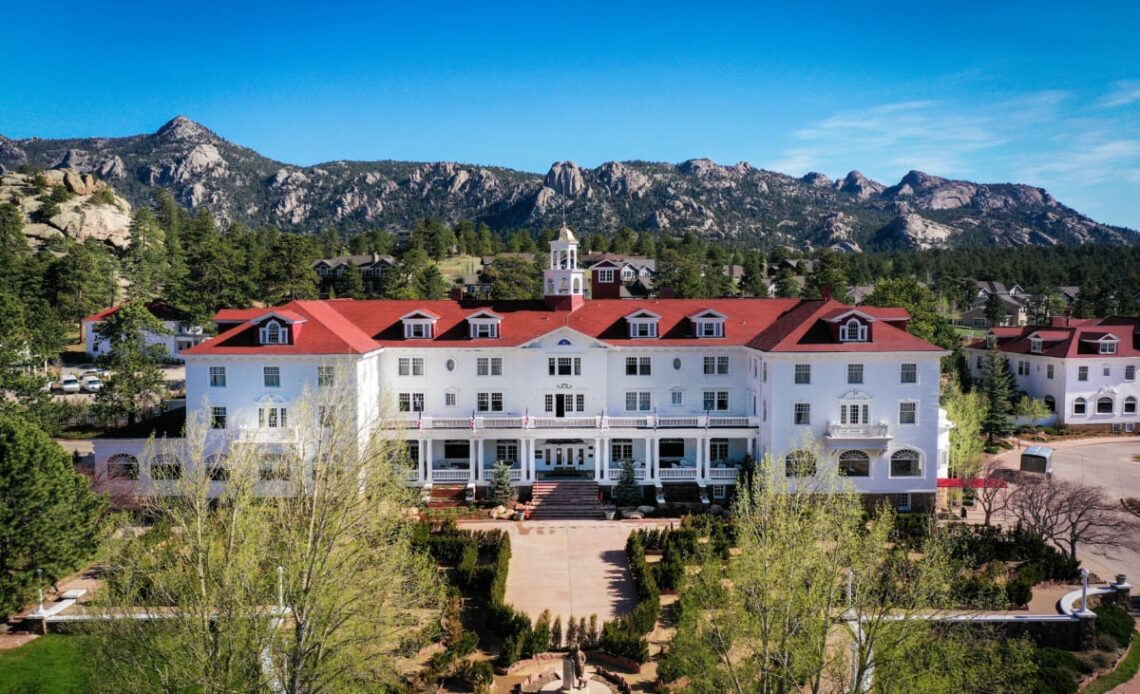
[96, 229, 950, 509]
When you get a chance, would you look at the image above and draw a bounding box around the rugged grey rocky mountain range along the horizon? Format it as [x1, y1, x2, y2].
[0, 116, 1140, 252]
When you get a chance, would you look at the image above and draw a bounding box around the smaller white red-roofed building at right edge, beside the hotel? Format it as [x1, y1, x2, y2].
[966, 317, 1140, 432]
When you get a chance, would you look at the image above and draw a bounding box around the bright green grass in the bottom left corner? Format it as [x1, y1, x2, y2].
[0, 634, 92, 694]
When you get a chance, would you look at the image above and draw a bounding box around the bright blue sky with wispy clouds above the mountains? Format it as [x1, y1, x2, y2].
[0, 0, 1140, 228]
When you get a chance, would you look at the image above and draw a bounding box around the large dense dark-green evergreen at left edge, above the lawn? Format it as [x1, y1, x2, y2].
[0, 413, 105, 615]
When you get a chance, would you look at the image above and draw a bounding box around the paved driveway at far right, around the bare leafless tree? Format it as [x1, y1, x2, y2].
[1001, 436, 1140, 585]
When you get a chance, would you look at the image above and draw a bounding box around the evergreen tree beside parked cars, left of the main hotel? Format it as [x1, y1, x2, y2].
[95, 302, 168, 425]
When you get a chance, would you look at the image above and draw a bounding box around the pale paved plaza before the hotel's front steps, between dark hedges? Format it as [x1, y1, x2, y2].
[463, 521, 652, 624]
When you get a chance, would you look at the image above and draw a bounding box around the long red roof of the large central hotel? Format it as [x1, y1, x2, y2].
[184, 299, 942, 354]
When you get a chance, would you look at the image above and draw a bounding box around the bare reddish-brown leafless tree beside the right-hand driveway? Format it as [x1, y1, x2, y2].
[1009, 477, 1140, 558]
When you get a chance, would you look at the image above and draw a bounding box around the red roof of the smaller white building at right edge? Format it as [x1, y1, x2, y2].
[967, 316, 1140, 359]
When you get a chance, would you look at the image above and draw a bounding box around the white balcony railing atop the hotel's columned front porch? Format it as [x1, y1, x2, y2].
[383, 415, 759, 430]
